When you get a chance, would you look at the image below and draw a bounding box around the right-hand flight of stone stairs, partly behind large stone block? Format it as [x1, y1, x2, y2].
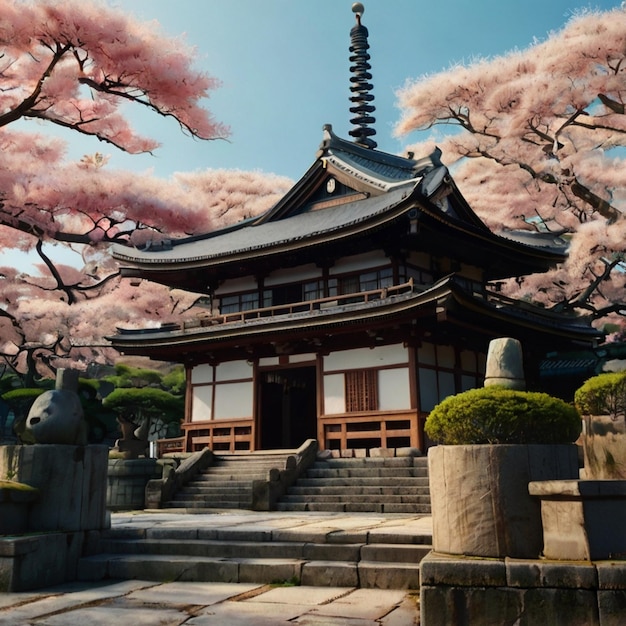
[277, 456, 431, 515]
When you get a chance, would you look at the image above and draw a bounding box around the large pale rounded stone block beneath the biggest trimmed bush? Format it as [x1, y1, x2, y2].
[428, 444, 578, 559]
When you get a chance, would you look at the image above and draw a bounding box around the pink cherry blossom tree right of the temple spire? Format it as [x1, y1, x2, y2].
[396, 9, 626, 334]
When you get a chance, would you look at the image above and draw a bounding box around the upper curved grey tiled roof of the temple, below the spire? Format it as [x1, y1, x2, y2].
[113, 126, 565, 292]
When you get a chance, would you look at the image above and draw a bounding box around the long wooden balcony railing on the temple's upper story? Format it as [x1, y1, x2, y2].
[185, 278, 414, 328]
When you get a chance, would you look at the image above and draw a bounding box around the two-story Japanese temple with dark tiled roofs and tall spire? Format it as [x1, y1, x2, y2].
[111, 4, 599, 451]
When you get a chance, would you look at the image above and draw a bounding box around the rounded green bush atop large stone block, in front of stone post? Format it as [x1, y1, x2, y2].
[425, 386, 581, 445]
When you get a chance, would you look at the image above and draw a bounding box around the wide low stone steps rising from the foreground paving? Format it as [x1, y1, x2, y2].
[78, 512, 431, 589]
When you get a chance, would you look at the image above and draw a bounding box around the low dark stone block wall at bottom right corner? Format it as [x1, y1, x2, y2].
[420, 552, 626, 626]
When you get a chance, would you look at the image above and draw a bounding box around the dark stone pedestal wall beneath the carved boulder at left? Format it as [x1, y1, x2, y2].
[0, 444, 111, 592]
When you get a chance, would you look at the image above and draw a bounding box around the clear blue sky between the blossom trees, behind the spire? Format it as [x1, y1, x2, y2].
[95, 0, 620, 179]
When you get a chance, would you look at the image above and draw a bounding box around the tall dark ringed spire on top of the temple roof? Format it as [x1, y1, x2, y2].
[349, 2, 377, 148]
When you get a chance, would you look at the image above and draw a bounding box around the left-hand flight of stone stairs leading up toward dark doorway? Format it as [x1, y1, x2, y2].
[163, 451, 293, 509]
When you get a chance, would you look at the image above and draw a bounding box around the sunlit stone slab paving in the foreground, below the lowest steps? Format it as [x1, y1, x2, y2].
[0, 580, 419, 626]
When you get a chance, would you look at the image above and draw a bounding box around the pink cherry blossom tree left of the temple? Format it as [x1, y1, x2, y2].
[0, 0, 287, 377]
